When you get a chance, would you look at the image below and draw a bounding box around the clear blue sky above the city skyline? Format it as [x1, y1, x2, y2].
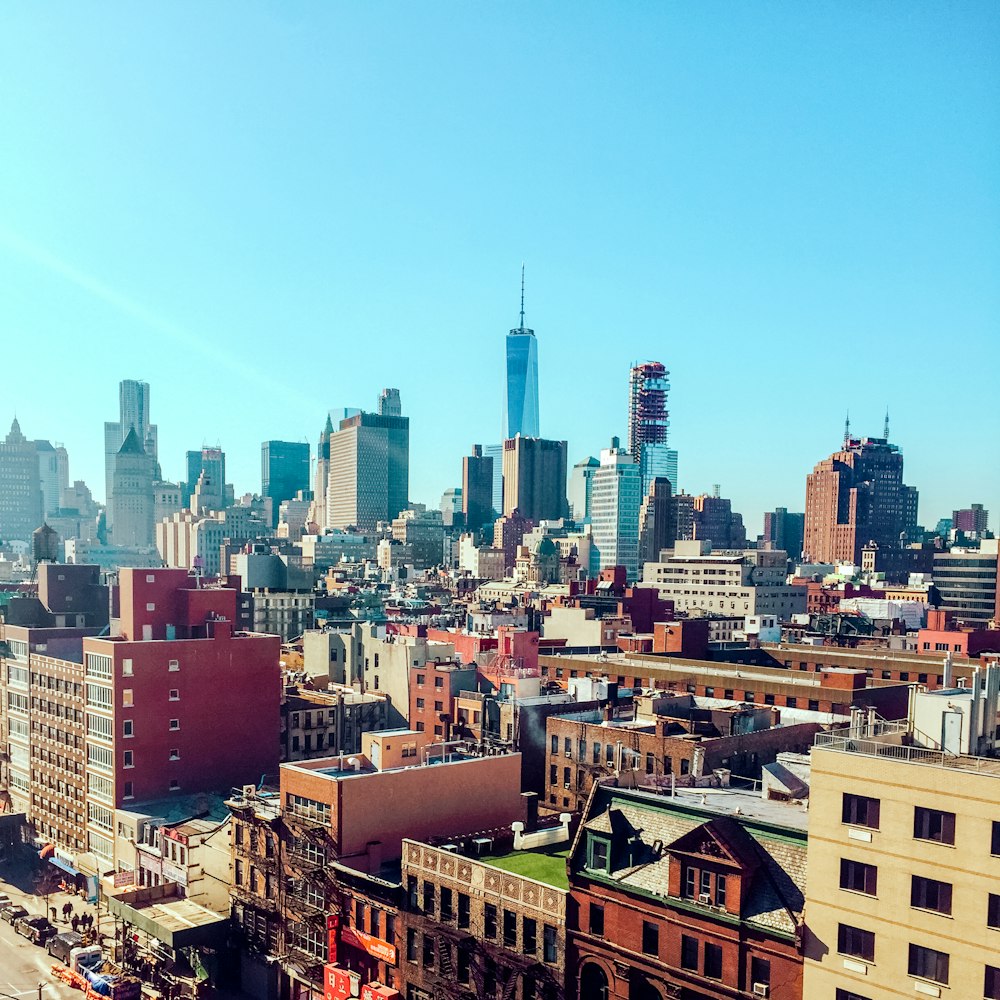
[0, 2, 1000, 533]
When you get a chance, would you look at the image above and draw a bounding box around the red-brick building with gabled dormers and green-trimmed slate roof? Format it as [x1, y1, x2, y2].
[567, 785, 806, 1000]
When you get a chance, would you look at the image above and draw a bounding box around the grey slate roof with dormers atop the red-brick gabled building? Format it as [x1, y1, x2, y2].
[583, 789, 806, 935]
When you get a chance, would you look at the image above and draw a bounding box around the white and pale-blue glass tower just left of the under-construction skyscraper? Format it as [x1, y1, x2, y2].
[590, 438, 642, 581]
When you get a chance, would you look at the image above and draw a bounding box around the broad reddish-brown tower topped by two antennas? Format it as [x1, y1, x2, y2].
[803, 425, 917, 565]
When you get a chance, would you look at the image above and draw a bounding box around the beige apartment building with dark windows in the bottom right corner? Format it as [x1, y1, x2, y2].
[803, 708, 1000, 1000]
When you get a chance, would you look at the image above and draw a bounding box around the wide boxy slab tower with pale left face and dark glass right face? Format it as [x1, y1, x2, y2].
[326, 390, 410, 531]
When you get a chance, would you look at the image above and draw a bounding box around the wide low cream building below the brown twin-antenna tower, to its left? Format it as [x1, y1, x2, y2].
[643, 541, 806, 621]
